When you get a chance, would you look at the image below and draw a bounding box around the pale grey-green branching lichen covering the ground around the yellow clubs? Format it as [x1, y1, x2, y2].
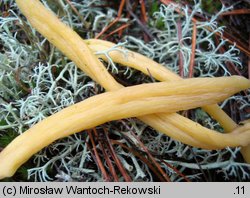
[0, 0, 250, 181]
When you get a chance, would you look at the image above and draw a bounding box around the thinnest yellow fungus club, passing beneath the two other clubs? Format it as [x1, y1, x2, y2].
[85, 39, 237, 132]
